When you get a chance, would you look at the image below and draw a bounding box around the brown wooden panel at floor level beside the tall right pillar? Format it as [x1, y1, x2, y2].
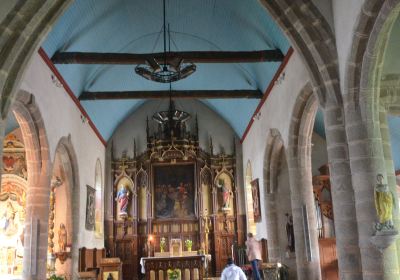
[318, 238, 339, 280]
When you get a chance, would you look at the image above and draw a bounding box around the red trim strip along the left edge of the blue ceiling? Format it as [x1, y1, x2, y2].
[38, 48, 107, 146]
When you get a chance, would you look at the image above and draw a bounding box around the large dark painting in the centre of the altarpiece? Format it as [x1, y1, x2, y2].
[154, 164, 196, 219]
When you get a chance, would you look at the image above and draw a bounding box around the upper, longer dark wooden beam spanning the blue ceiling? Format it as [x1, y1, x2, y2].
[51, 49, 284, 65]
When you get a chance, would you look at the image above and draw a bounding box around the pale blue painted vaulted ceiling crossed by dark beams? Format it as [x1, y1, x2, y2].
[42, 0, 290, 140]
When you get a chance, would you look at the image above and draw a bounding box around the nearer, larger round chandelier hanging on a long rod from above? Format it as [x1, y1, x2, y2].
[135, 0, 196, 83]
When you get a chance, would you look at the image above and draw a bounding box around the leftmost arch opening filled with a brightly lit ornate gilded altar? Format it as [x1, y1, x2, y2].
[0, 111, 28, 279]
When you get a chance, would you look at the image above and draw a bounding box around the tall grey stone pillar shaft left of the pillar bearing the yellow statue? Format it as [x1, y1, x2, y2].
[324, 100, 362, 279]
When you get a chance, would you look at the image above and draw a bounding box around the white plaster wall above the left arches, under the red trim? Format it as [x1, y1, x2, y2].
[21, 53, 105, 248]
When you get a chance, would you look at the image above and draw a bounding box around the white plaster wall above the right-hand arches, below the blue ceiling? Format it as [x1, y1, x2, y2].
[242, 52, 309, 239]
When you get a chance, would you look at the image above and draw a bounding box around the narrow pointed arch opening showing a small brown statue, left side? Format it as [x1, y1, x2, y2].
[47, 137, 80, 279]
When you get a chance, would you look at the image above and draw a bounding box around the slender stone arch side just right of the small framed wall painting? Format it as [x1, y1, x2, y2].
[264, 129, 284, 262]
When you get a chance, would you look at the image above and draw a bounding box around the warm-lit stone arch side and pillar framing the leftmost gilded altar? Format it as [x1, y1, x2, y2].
[12, 91, 51, 279]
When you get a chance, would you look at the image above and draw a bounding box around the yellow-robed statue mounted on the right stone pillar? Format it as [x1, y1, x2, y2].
[374, 174, 395, 231]
